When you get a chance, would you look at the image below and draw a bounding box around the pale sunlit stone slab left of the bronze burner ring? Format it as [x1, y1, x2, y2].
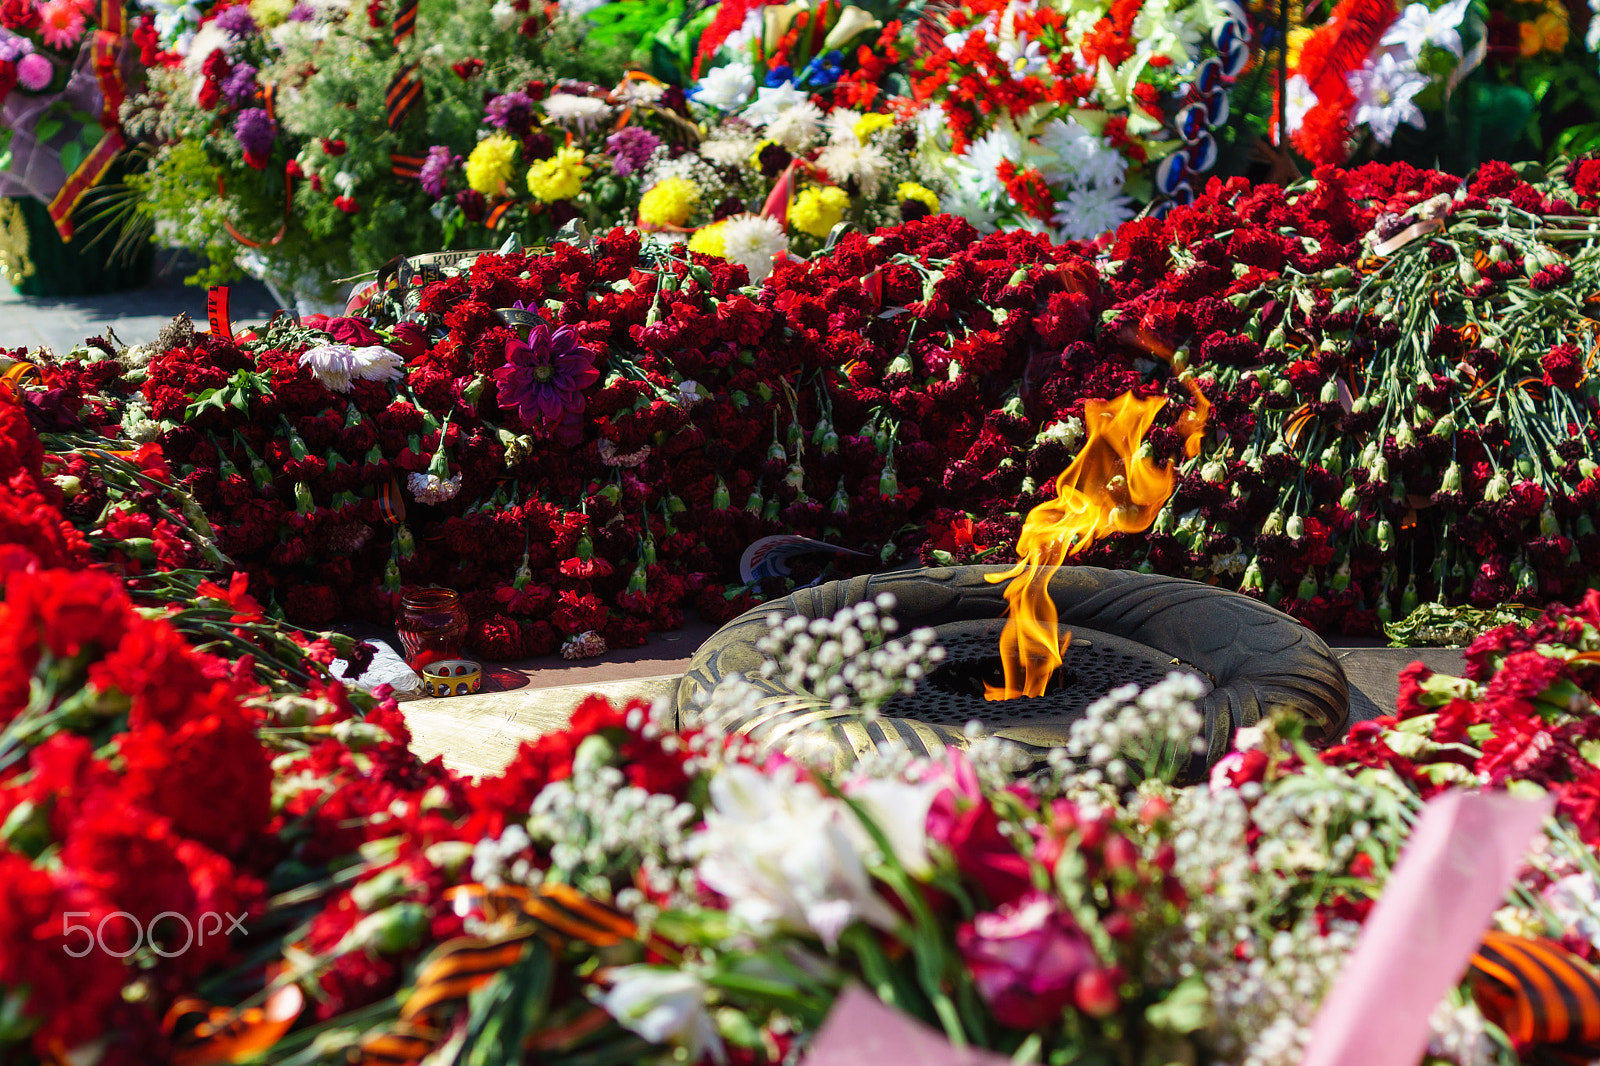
[400, 674, 678, 778]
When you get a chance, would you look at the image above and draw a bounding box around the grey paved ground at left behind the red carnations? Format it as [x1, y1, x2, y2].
[0, 256, 278, 352]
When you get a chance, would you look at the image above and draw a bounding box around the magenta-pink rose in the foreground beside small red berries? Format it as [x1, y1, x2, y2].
[955, 892, 1101, 1029]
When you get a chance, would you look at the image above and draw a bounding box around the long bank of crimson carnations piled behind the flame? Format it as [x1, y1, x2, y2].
[34, 160, 1600, 659]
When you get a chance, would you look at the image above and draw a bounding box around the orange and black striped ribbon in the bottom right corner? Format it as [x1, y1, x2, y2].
[1467, 932, 1600, 1063]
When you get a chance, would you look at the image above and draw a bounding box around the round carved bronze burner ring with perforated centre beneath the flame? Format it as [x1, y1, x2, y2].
[677, 567, 1350, 781]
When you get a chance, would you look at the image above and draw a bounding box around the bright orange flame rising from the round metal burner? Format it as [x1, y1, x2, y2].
[984, 383, 1211, 699]
